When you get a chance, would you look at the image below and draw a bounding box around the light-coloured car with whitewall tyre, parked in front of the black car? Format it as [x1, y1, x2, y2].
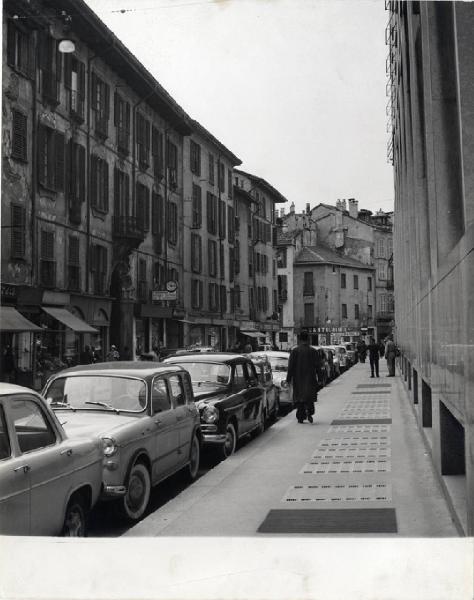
[44, 361, 202, 521]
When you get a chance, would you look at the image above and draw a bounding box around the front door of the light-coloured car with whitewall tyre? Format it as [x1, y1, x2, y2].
[151, 376, 179, 483]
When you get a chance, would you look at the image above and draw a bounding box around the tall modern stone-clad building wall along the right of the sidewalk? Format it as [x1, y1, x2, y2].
[386, 2, 474, 535]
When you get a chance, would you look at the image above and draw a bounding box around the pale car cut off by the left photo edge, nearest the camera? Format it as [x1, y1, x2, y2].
[0, 383, 103, 537]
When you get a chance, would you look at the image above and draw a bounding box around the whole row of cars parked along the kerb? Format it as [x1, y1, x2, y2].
[0, 347, 356, 536]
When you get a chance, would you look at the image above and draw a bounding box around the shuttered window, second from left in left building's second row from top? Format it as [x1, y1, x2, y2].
[38, 124, 65, 192]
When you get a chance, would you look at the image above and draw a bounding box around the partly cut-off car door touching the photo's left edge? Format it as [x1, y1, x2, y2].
[0, 397, 31, 535]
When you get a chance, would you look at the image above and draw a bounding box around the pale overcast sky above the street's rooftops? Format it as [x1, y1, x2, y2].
[86, 0, 393, 216]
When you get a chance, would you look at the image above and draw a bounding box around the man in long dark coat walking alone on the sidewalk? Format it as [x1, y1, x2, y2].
[286, 331, 321, 423]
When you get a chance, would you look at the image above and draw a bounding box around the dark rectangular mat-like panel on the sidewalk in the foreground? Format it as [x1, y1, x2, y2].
[257, 508, 398, 534]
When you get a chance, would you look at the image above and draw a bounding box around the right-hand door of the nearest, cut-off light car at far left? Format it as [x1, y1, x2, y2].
[10, 394, 75, 535]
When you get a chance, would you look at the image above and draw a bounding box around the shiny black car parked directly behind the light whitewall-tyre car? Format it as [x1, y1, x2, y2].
[165, 353, 265, 459]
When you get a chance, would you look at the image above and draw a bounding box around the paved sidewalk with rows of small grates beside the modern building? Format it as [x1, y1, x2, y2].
[125, 360, 458, 537]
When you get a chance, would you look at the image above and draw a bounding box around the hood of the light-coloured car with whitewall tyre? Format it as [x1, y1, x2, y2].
[55, 410, 139, 438]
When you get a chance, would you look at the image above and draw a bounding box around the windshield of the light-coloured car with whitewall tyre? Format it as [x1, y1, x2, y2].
[45, 375, 146, 412]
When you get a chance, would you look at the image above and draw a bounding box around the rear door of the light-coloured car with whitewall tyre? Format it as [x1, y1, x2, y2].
[167, 373, 197, 463]
